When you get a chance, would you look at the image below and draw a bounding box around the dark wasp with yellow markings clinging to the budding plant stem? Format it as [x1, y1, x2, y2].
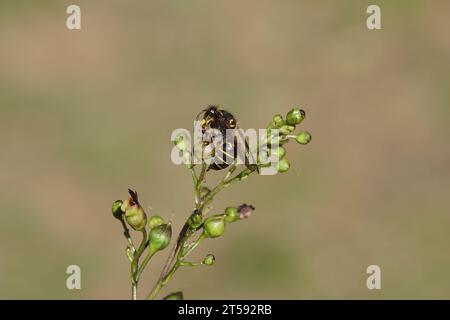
[196, 105, 257, 170]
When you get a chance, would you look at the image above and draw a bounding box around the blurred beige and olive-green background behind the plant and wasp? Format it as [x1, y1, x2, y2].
[0, 0, 450, 299]
